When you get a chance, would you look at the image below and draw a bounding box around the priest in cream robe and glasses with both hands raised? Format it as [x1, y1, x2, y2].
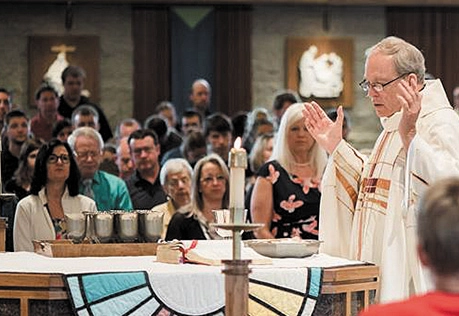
[303, 36, 459, 302]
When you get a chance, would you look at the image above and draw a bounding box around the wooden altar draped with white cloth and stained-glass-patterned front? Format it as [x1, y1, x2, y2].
[0, 252, 379, 316]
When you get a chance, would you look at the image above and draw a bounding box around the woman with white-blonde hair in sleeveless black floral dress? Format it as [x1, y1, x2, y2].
[250, 103, 327, 239]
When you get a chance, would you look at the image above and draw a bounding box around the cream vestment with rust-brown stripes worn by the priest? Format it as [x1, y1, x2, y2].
[319, 80, 459, 302]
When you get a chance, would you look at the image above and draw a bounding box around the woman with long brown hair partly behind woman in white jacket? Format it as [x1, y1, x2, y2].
[5, 139, 43, 200]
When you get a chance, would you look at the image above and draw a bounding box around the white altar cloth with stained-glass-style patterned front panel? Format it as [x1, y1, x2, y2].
[0, 252, 363, 315]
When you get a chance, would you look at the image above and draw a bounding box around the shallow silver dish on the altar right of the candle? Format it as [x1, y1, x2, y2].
[244, 238, 321, 258]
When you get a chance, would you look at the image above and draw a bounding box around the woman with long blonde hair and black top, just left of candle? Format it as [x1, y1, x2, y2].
[166, 154, 229, 240]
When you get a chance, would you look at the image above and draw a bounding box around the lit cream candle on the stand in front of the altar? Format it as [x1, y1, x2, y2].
[228, 137, 247, 260]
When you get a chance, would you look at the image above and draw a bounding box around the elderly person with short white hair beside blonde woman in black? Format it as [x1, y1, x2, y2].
[153, 158, 193, 239]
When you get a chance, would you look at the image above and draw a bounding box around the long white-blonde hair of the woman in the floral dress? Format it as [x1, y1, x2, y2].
[270, 103, 327, 176]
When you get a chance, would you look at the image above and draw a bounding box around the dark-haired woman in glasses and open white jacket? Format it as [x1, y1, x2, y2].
[13, 139, 97, 251]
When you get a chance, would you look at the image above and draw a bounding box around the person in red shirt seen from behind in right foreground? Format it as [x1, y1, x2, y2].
[361, 178, 459, 316]
